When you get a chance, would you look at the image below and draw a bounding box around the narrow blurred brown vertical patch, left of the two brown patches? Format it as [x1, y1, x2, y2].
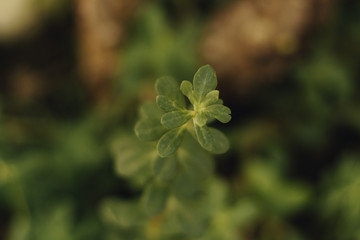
[75, 0, 142, 103]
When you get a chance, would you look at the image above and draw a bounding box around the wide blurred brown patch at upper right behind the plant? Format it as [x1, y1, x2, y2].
[201, 0, 331, 95]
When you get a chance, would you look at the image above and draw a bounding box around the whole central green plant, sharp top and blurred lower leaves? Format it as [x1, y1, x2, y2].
[102, 65, 231, 239]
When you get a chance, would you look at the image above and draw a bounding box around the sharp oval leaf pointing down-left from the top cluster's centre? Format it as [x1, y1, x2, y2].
[157, 128, 183, 157]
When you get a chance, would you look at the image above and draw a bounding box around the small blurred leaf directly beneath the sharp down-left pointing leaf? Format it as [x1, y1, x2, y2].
[153, 154, 177, 181]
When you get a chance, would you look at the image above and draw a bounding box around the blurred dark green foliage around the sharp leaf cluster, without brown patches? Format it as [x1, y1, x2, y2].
[0, 0, 360, 240]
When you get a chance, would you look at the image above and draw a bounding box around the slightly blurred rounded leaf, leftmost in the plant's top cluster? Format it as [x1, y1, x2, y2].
[135, 118, 166, 141]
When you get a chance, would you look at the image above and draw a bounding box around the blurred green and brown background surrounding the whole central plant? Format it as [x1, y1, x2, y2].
[0, 0, 360, 240]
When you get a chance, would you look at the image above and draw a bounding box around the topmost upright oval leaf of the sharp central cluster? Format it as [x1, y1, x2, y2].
[193, 65, 217, 102]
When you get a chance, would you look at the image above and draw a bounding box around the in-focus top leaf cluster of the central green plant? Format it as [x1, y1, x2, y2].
[135, 65, 231, 157]
